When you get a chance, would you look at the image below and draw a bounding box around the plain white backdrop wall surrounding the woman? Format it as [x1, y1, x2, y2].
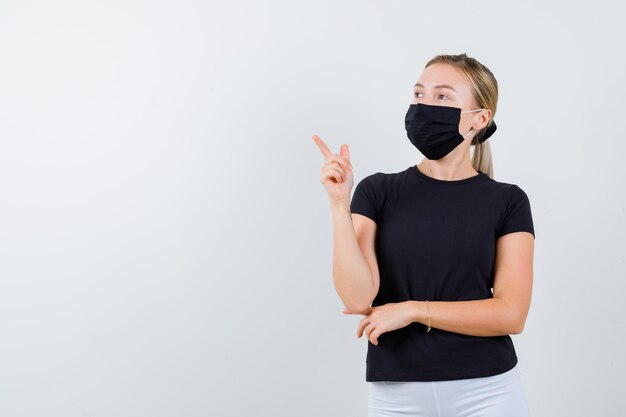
[0, 0, 626, 417]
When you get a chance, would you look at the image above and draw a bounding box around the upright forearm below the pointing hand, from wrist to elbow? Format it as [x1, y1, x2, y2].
[331, 201, 374, 312]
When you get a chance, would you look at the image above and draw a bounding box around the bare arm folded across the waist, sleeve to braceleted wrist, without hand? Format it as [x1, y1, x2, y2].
[405, 232, 535, 336]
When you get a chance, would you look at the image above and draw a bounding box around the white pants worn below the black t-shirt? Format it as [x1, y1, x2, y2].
[367, 365, 529, 417]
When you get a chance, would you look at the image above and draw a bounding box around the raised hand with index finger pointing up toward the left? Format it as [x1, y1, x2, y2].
[313, 135, 354, 203]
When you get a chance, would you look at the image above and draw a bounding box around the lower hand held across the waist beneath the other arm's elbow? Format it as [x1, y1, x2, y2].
[342, 301, 415, 346]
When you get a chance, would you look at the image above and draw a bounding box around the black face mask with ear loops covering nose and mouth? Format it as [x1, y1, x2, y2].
[404, 103, 497, 159]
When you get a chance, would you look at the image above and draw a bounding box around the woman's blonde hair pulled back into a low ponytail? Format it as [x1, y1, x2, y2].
[424, 53, 498, 178]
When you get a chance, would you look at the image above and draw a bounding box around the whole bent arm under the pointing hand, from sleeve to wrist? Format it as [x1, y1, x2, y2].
[330, 201, 380, 313]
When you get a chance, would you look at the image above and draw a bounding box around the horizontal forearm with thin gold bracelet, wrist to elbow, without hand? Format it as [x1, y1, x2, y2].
[407, 298, 524, 336]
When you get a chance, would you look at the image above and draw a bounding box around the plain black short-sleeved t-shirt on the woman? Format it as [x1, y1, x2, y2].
[350, 165, 535, 381]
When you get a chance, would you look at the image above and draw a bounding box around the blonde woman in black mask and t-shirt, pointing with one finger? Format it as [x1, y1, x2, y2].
[313, 54, 535, 417]
